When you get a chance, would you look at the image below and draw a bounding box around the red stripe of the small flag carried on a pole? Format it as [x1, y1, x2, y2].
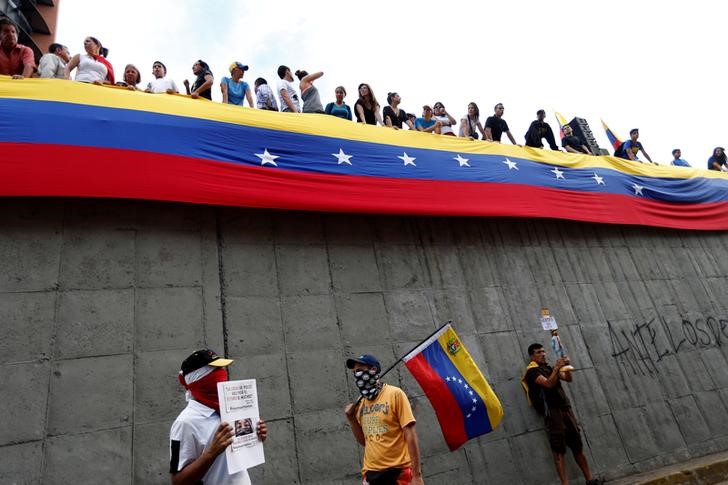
[405, 352, 468, 450]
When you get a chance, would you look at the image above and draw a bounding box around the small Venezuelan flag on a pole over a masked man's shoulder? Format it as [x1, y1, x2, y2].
[402, 324, 503, 451]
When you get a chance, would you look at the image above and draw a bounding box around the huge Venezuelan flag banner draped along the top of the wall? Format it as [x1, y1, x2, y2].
[0, 76, 728, 229]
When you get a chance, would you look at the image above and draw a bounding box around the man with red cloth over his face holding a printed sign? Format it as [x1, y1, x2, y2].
[169, 349, 268, 485]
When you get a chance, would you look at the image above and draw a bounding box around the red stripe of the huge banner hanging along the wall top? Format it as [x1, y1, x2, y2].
[0, 143, 728, 229]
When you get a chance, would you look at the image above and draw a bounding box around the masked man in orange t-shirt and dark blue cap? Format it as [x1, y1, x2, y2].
[344, 354, 424, 485]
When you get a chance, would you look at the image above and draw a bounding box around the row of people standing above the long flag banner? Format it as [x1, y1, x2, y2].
[0, 19, 728, 172]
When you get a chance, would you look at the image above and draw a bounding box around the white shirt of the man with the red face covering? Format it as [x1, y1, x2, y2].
[169, 400, 251, 485]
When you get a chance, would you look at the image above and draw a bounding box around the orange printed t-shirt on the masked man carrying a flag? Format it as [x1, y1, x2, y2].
[356, 384, 415, 473]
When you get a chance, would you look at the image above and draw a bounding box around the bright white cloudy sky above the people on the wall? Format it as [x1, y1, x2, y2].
[57, 0, 728, 167]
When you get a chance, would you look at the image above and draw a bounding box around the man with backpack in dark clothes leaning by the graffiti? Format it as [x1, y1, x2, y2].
[521, 343, 603, 485]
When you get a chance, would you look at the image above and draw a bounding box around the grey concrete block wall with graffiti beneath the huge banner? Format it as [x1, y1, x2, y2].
[0, 199, 728, 485]
